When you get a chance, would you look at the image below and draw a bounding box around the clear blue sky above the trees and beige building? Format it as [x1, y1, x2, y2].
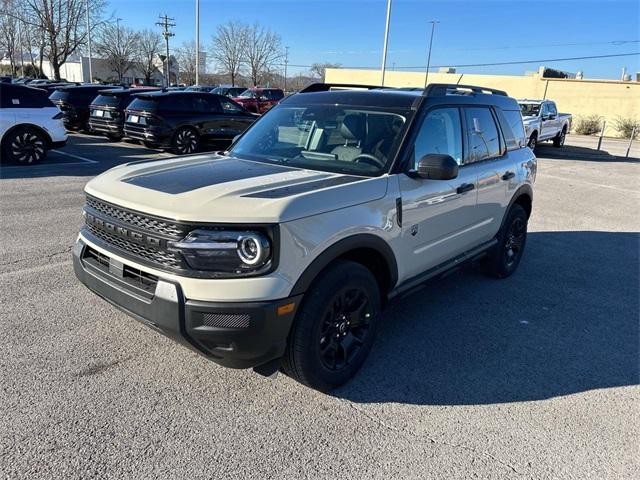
[107, 0, 640, 78]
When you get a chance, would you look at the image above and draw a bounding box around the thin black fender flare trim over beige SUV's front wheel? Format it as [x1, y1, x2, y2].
[290, 233, 398, 296]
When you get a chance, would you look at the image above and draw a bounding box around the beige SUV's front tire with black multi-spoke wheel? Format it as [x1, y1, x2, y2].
[282, 260, 381, 392]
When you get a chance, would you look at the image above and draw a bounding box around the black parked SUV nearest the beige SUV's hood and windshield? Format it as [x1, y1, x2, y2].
[124, 91, 257, 155]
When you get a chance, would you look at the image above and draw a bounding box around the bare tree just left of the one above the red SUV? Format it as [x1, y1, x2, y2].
[211, 21, 249, 86]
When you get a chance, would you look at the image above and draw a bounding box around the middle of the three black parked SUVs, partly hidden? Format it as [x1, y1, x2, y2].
[89, 87, 160, 140]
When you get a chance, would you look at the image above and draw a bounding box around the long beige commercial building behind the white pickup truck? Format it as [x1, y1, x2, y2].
[325, 68, 640, 137]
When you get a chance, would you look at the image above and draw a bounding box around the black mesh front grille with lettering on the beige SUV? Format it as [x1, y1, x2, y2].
[85, 195, 190, 270]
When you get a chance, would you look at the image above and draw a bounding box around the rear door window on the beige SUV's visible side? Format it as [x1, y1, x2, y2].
[464, 107, 500, 163]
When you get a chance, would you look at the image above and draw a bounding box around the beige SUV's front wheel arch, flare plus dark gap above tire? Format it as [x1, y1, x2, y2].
[291, 233, 398, 299]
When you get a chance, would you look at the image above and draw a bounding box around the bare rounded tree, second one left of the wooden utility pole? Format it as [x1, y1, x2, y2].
[95, 23, 138, 82]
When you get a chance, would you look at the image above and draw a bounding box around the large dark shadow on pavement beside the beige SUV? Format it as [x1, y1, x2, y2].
[334, 231, 640, 405]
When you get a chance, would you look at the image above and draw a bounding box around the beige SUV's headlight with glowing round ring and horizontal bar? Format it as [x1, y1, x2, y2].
[170, 229, 272, 275]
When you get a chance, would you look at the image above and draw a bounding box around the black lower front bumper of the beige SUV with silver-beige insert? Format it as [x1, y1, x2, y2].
[73, 239, 302, 368]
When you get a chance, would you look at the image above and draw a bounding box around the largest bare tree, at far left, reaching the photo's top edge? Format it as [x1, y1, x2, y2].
[21, 0, 105, 80]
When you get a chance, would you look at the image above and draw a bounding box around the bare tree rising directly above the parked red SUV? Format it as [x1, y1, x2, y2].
[244, 23, 284, 86]
